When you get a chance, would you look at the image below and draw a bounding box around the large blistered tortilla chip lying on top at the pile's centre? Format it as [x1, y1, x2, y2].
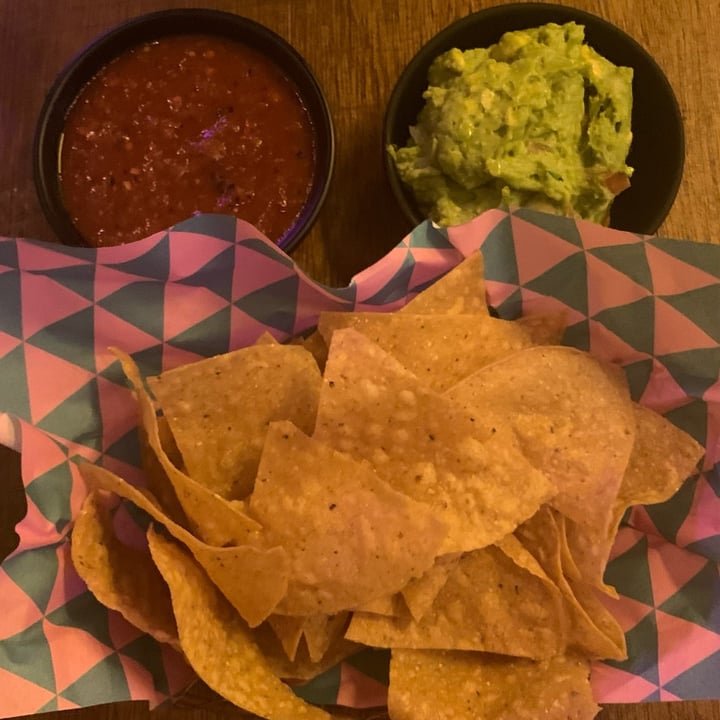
[314, 329, 555, 554]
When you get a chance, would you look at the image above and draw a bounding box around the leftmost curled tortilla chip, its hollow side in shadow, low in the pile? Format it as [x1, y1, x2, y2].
[70, 492, 180, 649]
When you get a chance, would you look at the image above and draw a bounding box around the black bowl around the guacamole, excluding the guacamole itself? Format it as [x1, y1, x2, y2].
[383, 3, 685, 235]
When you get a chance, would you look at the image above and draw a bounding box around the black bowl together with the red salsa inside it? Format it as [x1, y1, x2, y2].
[35, 10, 333, 249]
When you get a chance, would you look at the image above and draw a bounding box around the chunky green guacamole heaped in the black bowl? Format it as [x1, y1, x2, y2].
[389, 23, 632, 225]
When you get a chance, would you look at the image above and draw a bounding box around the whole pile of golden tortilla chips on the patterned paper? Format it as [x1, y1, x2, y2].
[72, 253, 702, 720]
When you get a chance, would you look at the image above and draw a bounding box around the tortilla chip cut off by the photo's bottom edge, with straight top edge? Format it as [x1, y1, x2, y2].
[388, 650, 600, 720]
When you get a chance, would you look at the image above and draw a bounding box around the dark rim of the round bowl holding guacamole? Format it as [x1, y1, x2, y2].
[382, 2, 685, 235]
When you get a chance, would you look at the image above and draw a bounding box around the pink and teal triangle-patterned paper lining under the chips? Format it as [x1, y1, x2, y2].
[0, 210, 720, 717]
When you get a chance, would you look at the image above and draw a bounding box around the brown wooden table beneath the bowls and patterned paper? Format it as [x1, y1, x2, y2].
[0, 0, 720, 720]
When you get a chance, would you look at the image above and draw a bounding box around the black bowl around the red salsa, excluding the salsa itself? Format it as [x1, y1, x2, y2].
[33, 9, 335, 252]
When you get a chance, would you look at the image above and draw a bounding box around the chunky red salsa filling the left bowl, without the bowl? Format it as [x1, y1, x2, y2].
[60, 35, 315, 246]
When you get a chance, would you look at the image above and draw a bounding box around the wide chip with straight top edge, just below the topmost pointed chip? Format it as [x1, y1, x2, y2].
[318, 312, 533, 392]
